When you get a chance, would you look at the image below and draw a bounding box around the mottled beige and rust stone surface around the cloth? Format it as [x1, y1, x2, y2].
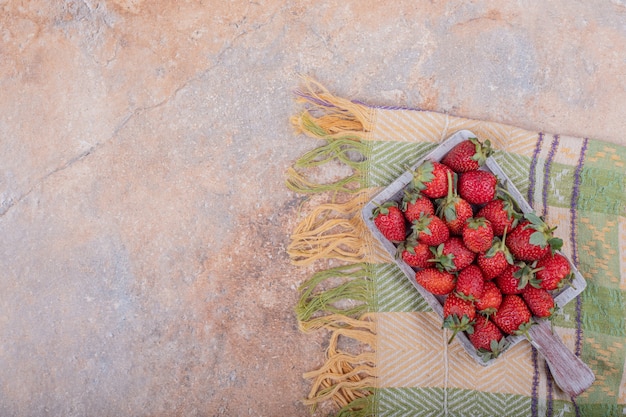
[0, 0, 626, 416]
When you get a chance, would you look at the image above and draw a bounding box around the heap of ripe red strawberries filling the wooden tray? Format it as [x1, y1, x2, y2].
[373, 138, 572, 361]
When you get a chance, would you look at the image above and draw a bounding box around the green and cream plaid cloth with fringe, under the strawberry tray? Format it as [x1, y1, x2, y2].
[287, 80, 626, 417]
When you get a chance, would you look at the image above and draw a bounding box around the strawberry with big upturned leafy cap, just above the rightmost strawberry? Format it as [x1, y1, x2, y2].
[506, 213, 563, 261]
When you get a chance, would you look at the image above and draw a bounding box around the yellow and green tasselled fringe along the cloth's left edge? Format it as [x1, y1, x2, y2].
[287, 78, 390, 417]
